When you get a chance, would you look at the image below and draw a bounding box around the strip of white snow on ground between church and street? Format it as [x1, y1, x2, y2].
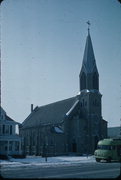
[0, 156, 95, 167]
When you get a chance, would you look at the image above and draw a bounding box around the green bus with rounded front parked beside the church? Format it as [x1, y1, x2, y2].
[94, 138, 121, 162]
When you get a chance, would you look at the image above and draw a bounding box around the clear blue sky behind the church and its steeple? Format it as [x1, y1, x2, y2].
[1, 0, 121, 126]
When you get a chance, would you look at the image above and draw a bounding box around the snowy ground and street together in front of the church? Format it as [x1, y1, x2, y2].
[0, 156, 120, 178]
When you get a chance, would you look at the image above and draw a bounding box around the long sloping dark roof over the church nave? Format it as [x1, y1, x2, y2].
[22, 96, 77, 128]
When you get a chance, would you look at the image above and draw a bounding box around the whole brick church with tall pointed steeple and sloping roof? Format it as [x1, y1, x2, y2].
[19, 28, 107, 157]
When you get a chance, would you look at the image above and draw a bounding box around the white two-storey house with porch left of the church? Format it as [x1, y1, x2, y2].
[0, 107, 22, 157]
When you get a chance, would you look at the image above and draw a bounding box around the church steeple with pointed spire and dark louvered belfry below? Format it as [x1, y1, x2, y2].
[79, 27, 99, 91]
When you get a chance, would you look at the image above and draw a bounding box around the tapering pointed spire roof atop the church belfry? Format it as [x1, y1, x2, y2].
[82, 32, 97, 73]
